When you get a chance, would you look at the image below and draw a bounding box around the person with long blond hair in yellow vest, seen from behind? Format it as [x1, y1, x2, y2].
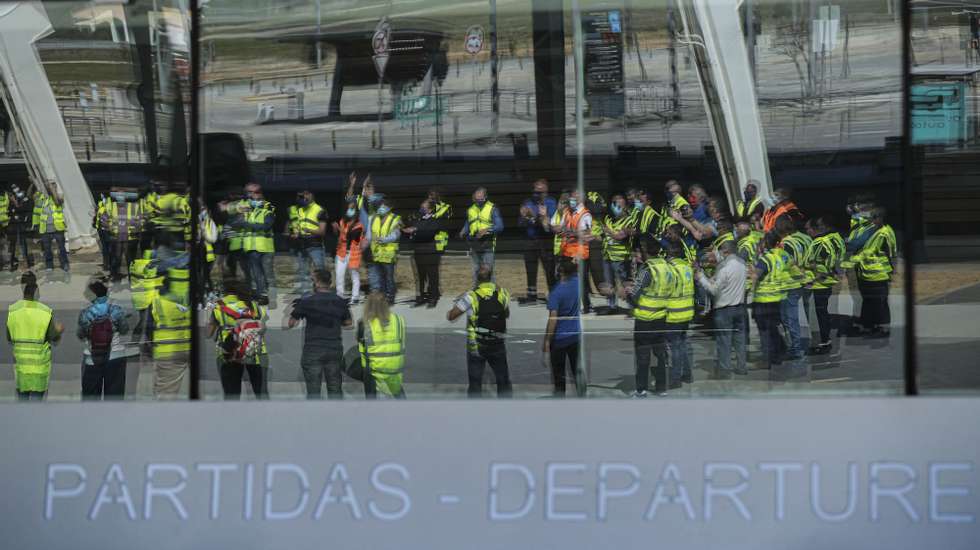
[348, 294, 406, 399]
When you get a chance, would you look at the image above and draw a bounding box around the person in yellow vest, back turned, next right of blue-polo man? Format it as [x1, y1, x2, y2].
[621, 235, 680, 398]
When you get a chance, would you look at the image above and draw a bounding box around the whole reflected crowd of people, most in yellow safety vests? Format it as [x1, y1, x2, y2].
[0, 174, 897, 399]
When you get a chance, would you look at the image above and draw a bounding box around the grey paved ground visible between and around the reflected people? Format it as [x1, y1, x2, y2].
[0, 252, 944, 399]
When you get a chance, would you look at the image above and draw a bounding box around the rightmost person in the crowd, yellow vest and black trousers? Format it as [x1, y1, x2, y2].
[850, 206, 898, 338]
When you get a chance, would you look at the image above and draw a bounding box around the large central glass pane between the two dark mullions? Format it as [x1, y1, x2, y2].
[198, 0, 904, 398]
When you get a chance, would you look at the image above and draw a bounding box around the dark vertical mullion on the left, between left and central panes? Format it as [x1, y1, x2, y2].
[189, 0, 204, 401]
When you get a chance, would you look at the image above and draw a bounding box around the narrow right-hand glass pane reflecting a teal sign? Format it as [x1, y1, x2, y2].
[909, 6, 980, 393]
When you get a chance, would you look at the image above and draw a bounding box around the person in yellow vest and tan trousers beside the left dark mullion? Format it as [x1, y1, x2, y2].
[148, 267, 194, 399]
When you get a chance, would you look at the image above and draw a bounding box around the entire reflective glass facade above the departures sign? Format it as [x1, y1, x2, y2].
[0, 0, 980, 399]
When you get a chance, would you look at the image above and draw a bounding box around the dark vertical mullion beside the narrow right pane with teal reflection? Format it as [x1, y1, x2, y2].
[900, 0, 925, 395]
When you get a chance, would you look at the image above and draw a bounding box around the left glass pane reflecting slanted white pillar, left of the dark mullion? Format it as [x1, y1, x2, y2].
[0, 1, 189, 400]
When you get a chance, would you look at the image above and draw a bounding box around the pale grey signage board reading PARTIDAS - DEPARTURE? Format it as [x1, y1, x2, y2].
[0, 397, 980, 550]
